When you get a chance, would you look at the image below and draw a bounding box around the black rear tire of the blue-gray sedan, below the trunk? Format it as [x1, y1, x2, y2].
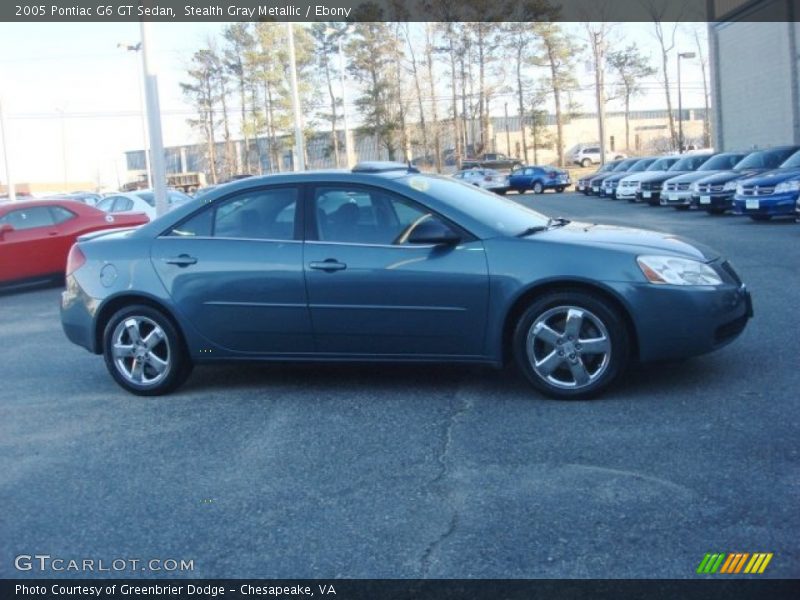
[103, 304, 193, 396]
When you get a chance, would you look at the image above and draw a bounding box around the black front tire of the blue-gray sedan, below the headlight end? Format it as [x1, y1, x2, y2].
[512, 290, 630, 400]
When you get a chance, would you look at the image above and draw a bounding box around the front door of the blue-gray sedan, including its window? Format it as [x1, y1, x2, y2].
[304, 184, 489, 358]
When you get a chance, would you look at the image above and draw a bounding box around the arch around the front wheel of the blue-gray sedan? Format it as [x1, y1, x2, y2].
[501, 280, 639, 364]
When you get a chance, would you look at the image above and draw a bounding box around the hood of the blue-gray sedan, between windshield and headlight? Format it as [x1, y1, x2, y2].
[529, 221, 719, 262]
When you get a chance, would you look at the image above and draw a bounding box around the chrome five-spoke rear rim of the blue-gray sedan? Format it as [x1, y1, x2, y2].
[111, 316, 172, 386]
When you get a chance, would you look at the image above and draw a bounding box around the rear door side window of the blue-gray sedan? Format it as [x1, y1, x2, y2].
[170, 188, 297, 240]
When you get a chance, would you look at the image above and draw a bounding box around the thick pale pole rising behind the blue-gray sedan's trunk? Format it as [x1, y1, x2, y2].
[141, 21, 169, 217]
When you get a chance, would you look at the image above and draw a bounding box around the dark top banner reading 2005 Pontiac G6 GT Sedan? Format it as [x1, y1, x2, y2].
[0, 0, 800, 22]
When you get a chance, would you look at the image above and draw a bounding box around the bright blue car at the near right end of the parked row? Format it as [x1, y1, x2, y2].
[733, 151, 800, 221]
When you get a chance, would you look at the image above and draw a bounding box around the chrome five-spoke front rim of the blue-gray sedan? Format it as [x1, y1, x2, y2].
[525, 306, 611, 389]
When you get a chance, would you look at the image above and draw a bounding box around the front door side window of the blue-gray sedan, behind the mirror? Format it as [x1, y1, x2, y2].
[314, 185, 430, 244]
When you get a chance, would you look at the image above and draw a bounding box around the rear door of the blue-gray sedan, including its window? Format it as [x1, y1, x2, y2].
[151, 186, 313, 355]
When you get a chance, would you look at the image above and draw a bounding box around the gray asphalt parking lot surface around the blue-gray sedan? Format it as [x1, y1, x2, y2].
[0, 193, 800, 578]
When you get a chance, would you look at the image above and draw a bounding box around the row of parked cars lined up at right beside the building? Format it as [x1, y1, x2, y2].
[576, 146, 800, 221]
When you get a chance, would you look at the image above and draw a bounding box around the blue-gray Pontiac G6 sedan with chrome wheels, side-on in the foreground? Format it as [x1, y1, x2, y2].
[61, 164, 752, 399]
